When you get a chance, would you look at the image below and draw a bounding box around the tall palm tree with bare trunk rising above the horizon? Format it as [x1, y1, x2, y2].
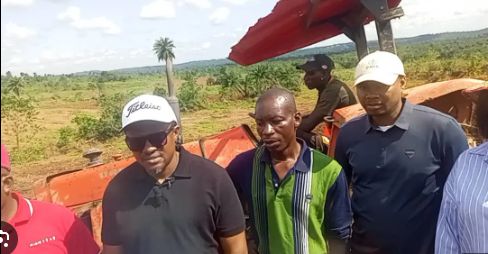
[153, 37, 175, 98]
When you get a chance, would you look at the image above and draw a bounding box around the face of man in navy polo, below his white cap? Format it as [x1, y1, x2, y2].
[356, 77, 405, 116]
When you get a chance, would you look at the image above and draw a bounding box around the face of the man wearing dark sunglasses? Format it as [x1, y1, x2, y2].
[124, 121, 179, 177]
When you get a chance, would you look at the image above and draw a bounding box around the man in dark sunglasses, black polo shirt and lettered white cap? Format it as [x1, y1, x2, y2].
[102, 95, 247, 254]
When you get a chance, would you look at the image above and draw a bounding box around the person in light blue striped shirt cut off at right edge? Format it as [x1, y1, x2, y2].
[435, 83, 488, 254]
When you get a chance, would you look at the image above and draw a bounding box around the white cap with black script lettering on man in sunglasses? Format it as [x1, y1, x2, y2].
[122, 94, 177, 129]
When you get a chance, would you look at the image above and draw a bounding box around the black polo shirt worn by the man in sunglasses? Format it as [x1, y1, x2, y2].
[102, 149, 245, 254]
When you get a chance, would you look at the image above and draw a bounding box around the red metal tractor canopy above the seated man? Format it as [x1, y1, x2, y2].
[229, 0, 400, 65]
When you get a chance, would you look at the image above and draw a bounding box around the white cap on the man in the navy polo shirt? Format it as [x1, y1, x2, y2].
[354, 51, 405, 86]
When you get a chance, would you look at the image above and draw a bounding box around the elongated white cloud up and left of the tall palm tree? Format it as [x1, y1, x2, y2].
[58, 6, 121, 34]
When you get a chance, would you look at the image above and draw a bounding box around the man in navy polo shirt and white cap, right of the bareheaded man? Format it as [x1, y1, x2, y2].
[336, 51, 468, 254]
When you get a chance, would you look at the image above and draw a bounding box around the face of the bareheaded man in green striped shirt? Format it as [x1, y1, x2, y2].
[255, 96, 301, 152]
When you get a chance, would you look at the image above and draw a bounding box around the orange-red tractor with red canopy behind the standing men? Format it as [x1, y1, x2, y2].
[29, 0, 486, 245]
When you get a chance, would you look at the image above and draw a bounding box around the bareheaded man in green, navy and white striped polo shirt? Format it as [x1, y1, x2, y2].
[228, 88, 352, 254]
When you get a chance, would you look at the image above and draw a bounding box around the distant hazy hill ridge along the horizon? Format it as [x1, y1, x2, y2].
[74, 28, 488, 76]
